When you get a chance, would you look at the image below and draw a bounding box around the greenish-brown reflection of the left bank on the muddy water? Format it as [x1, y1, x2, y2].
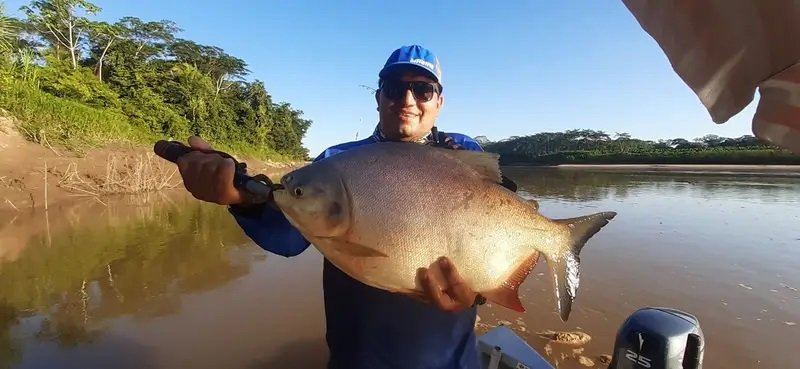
[0, 193, 252, 367]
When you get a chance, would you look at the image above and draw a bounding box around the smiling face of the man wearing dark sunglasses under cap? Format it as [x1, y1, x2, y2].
[376, 73, 444, 141]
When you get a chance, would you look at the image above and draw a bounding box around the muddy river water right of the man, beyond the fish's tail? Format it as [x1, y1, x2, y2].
[482, 167, 800, 369]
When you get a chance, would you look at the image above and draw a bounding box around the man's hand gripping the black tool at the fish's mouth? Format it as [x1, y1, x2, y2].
[176, 136, 250, 205]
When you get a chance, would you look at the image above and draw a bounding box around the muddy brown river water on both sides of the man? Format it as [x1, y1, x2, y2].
[0, 168, 800, 369]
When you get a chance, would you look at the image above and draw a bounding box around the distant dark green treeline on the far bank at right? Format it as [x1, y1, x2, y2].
[477, 129, 800, 165]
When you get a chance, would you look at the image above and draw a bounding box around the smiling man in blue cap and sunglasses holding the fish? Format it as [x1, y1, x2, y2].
[178, 45, 510, 369]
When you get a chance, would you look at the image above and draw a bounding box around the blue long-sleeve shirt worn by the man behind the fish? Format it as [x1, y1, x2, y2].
[228, 133, 483, 369]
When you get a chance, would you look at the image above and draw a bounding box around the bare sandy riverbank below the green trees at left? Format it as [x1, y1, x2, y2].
[0, 117, 305, 219]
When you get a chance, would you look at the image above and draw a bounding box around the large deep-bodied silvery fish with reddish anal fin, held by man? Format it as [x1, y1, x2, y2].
[274, 142, 616, 321]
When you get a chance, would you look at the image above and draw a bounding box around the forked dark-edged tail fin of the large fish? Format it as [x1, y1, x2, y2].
[544, 211, 617, 322]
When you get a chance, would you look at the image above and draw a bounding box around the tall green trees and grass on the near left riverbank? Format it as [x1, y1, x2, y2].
[0, 0, 312, 160]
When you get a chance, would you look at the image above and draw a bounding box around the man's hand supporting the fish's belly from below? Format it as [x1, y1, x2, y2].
[417, 257, 478, 313]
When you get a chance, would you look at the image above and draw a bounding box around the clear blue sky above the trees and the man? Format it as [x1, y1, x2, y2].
[6, 0, 755, 156]
